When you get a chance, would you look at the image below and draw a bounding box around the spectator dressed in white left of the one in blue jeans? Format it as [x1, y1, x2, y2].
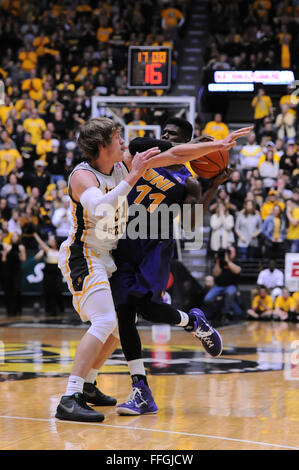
[210, 202, 234, 252]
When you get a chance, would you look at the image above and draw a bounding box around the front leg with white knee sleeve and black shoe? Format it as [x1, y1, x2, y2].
[56, 287, 117, 421]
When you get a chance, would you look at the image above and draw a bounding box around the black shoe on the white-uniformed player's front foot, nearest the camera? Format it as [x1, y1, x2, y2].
[55, 393, 105, 422]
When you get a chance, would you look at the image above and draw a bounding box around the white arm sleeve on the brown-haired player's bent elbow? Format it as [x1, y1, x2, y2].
[80, 181, 132, 217]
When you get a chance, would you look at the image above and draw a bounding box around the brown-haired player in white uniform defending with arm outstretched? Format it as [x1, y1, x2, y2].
[55, 118, 251, 421]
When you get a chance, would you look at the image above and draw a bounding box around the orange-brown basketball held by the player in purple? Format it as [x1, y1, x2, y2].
[190, 150, 229, 179]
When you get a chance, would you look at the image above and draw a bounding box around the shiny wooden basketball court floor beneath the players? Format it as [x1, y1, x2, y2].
[0, 318, 299, 450]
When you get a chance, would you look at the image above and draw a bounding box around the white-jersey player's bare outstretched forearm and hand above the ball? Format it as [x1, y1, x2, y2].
[145, 126, 253, 168]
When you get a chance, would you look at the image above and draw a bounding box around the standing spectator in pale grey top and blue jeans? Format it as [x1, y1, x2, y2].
[235, 200, 262, 261]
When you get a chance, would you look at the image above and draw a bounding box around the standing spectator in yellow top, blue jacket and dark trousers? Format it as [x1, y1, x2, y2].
[262, 205, 286, 258]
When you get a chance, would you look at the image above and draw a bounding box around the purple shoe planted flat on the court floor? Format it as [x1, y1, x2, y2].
[116, 380, 158, 415]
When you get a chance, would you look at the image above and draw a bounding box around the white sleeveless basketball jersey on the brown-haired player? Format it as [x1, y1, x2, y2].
[68, 162, 128, 254]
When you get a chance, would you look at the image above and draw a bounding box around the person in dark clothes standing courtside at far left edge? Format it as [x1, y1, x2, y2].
[2, 233, 26, 315]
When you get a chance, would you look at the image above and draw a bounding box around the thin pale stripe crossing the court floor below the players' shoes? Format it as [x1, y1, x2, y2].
[0, 416, 299, 450]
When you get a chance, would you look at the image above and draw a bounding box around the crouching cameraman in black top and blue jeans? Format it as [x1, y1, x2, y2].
[204, 246, 245, 318]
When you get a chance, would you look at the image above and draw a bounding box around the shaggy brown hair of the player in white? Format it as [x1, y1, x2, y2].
[77, 118, 119, 161]
